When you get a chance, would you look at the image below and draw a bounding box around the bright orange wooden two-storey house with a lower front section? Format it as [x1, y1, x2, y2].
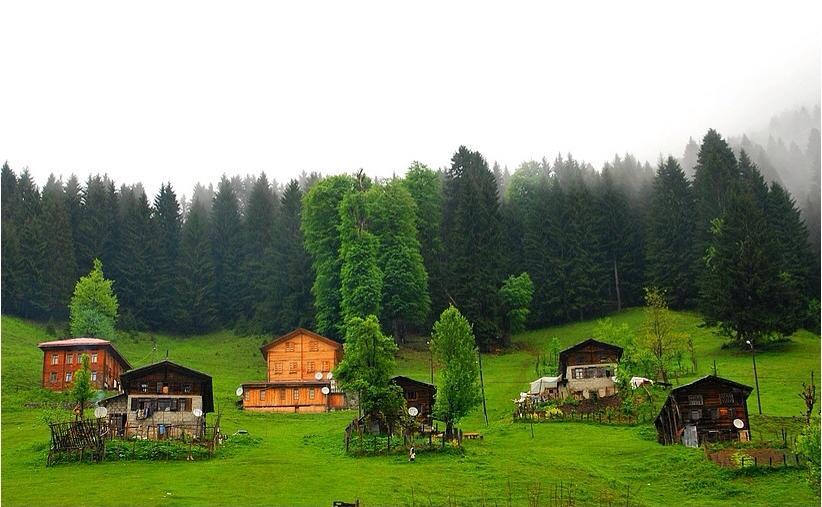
[242, 328, 346, 412]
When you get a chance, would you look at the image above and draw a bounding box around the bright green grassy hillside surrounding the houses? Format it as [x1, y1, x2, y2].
[2, 310, 820, 506]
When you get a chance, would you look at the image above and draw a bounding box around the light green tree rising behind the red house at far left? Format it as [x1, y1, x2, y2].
[69, 259, 119, 338]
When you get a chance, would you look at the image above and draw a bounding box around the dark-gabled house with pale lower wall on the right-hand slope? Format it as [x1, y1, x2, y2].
[558, 338, 622, 399]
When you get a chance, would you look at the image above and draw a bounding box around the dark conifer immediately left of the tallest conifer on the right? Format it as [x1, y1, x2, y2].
[646, 157, 699, 308]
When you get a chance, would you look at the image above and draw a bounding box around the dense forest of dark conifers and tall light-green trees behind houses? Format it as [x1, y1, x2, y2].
[2, 125, 820, 349]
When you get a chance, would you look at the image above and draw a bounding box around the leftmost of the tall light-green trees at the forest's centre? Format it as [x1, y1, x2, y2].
[301, 175, 356, 340]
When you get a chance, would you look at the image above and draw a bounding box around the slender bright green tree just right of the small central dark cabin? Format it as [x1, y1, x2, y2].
[431, 306, 482, 438]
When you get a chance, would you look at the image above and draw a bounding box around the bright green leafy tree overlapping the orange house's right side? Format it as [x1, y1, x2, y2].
[334, 315, 404, 425]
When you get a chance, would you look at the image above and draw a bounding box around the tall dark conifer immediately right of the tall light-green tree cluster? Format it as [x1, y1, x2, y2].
[442, 146, 501, 348]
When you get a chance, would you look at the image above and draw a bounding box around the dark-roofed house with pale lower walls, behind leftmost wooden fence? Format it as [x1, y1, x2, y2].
[100, 359, 214, 438]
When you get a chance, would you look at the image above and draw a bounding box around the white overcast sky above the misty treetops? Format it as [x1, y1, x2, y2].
[0, 1, 822, 195]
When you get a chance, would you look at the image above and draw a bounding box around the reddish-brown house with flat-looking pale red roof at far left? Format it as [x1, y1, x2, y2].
[37, 338, 131, 391]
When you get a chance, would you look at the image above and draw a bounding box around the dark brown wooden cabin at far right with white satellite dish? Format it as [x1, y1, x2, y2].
[654, 375, 753, 447]
